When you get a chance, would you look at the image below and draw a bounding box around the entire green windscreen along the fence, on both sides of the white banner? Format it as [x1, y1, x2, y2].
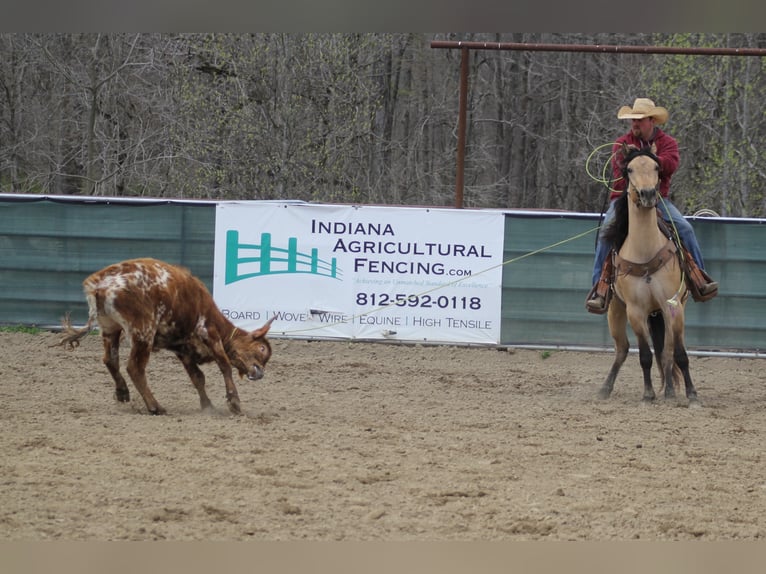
[0, 195, 766, 352]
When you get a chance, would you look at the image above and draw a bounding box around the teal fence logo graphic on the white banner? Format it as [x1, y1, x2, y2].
[226, 229, 343, 285]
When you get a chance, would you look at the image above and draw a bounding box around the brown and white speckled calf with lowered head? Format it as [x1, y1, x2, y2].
[60, 259, 274, 415]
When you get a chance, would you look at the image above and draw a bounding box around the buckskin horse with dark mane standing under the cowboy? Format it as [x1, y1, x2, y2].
[599, 146, 699, 406]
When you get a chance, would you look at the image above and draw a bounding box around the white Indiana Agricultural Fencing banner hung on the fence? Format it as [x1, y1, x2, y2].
[213, 202, 504, 344]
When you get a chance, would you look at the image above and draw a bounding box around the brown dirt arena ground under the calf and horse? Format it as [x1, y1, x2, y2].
[0, 332, 766, 541]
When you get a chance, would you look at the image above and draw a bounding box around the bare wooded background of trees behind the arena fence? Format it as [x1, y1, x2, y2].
[0, 33, 766, 217]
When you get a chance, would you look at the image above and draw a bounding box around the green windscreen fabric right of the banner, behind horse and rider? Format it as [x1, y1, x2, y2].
[501, 214, 766, 352]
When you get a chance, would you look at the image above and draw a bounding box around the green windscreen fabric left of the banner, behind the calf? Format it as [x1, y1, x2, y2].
[0, 200, 215, 327]
